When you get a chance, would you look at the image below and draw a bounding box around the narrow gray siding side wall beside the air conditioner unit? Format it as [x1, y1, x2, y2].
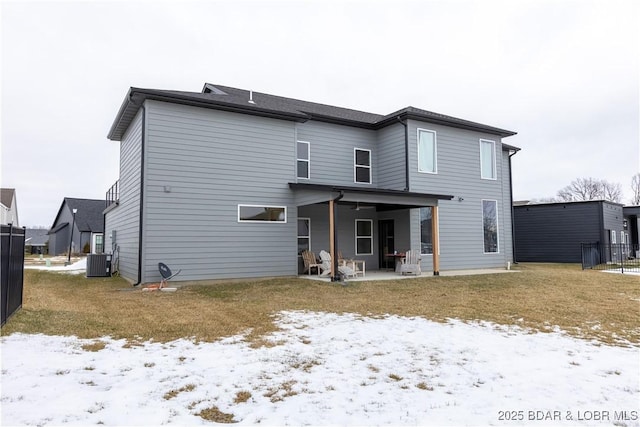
[104, 110, 143, 282]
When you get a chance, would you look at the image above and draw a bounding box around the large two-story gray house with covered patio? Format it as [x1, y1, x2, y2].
[105, 84, 518, 283]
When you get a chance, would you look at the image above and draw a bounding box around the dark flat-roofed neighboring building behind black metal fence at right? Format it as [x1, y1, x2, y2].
[513, 200, 628, 262]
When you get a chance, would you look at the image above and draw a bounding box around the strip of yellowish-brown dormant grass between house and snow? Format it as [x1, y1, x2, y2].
[2, 264, 640, 345]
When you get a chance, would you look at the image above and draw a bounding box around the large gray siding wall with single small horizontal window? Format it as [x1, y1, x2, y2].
[143, 101, 298, 282]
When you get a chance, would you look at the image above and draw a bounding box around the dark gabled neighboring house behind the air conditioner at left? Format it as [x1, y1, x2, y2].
[49, 197, 105, 255]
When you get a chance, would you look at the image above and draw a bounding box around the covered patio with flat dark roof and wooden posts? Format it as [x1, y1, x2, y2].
[289, 183, 453, 281]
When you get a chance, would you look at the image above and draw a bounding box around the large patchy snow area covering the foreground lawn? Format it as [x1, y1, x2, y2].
[0, 311, 640, 426]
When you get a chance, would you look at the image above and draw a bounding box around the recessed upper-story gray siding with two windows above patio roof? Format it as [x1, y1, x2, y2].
[291, 121, 378, 188]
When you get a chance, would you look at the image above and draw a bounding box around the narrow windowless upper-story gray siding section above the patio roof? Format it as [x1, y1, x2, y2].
[377, 123, 406, 190]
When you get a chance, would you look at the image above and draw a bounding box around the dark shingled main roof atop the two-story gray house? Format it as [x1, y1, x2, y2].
[108, 83, 516, 141]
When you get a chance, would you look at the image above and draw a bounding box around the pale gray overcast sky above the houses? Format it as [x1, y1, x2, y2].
[0, 0, 640, 226]
